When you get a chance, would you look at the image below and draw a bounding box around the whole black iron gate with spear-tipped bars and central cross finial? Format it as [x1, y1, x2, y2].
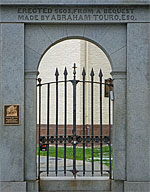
[37, 64, 112, 179]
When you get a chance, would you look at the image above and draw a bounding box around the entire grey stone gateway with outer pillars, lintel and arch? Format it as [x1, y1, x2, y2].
[0, 0, 150, 192]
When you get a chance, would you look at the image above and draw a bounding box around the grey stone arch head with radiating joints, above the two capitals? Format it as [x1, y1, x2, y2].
[25, 25, 126, 71]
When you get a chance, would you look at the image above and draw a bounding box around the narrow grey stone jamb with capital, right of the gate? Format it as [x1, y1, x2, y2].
[112, 72, 127, 192]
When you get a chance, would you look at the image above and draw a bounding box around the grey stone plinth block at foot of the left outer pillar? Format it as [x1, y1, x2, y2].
[0, 182, 26, 192]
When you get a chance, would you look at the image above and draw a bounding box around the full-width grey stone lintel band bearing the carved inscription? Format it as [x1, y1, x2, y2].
[0, 4, 150, 24]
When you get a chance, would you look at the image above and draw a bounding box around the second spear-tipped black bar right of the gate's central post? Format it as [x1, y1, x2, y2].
[90, 68, 94, 176]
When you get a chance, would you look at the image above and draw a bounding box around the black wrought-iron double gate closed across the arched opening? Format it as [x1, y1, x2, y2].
[37, 64, 113, 179]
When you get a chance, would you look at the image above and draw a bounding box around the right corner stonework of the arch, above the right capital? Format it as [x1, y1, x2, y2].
[99, 25, 127, 71]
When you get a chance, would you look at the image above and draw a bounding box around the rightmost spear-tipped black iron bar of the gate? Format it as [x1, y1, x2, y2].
[99, 69, 103, 176]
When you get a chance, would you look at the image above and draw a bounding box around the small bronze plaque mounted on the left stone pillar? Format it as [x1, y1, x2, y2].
[4, 105, 20, 125]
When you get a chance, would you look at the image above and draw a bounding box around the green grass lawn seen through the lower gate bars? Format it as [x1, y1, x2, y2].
[37, 146, 112, 166]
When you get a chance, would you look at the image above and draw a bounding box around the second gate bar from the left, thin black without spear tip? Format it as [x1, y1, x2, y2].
[47, 84, 50, 176]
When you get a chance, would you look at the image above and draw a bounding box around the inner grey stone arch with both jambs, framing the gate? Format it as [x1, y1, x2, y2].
[25, 25, 126, 190]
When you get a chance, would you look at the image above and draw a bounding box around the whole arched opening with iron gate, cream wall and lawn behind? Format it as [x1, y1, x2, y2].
[37, 39, 113, 178]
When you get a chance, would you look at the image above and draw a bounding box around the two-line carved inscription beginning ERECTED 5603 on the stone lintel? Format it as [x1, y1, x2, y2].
[18, 7, 136, 22]
